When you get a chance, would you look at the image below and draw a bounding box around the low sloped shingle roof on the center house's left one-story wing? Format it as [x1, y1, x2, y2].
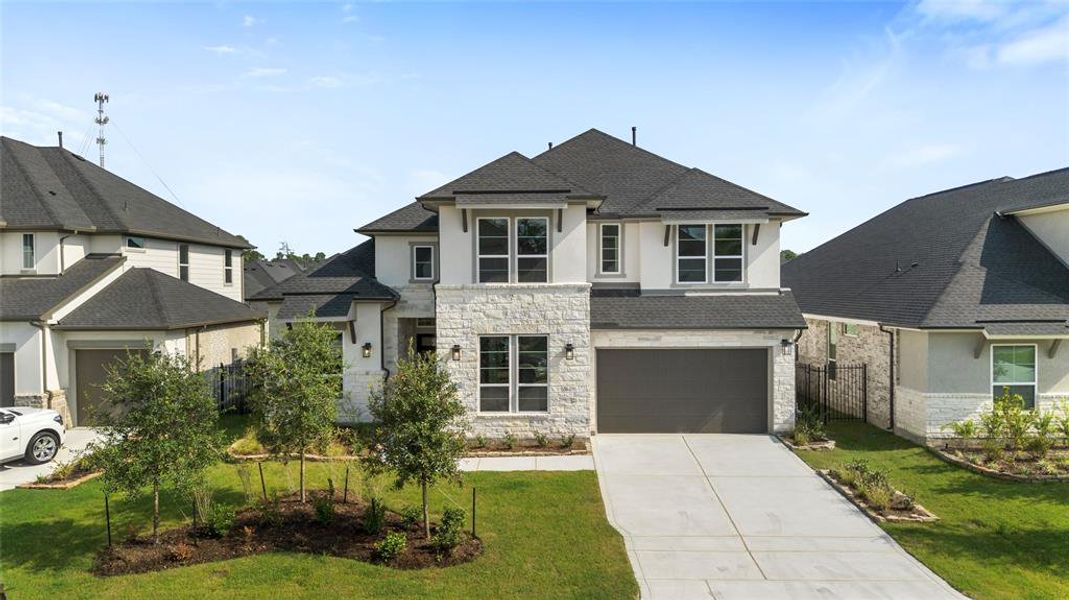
[249, 240, 398, 301]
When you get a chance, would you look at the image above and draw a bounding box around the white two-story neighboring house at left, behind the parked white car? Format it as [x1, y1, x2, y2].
[0, 137, 263, 426]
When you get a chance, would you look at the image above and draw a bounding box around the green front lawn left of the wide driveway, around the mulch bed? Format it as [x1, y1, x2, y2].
[0, 447, 638, 600]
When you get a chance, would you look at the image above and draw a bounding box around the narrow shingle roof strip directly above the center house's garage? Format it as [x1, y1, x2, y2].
[590, 289, 806, 329]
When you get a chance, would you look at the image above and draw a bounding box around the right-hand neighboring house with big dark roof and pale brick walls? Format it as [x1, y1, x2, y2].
[783, 169, 1069, 440]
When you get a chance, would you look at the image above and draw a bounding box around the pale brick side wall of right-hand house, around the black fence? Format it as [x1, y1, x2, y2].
[799, 318, 897, 428]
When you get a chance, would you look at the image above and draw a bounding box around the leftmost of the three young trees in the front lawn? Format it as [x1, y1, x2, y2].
[94, 352, 222, 543]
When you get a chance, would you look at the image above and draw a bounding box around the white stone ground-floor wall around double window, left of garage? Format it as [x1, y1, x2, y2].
[435, 283, 592, 440]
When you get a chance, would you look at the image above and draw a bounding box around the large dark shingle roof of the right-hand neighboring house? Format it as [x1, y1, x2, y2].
[783, 169, 1069, 330]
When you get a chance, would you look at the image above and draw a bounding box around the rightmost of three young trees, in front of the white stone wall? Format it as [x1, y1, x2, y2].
[363, 344, 465, 539]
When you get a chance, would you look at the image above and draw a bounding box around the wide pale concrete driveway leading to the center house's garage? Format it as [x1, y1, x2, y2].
[593, 434, 962, 600]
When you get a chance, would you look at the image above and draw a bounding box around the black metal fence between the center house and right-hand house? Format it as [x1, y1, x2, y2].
[794, 363, 868, 422]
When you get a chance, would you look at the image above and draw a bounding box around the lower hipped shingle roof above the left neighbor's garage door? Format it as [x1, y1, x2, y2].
[56, 268, 265, 330]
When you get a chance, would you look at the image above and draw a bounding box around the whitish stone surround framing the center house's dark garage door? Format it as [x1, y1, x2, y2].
[590, 329, 794, 432]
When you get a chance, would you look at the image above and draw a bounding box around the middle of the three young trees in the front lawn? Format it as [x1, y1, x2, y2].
[246, 316, 342, 502]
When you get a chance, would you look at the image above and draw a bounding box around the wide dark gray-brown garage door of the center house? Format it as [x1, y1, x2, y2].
[598, 349, 769, 433]
